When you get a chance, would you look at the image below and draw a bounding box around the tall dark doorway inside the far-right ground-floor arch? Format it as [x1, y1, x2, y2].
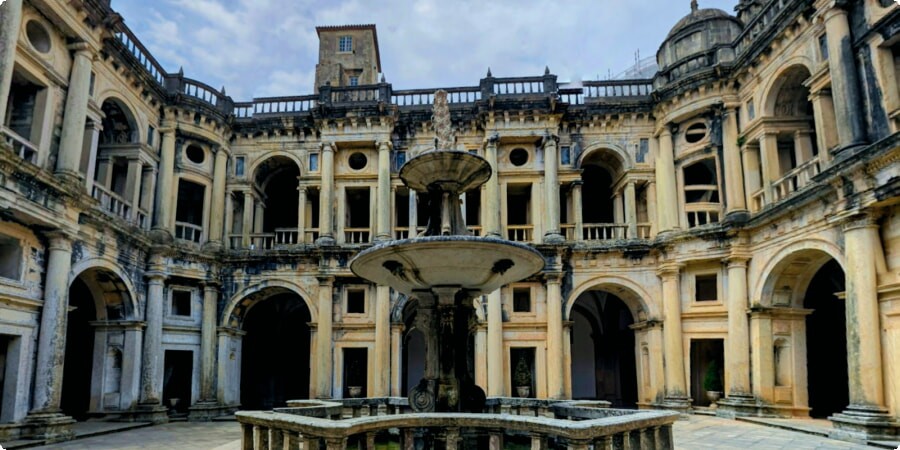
[803, 259, 850, 418]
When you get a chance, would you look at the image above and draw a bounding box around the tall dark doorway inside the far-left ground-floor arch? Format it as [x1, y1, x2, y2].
[60, 278, 97, 421]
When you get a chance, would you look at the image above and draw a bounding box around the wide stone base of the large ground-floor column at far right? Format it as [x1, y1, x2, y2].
[828, 405, 900, 441]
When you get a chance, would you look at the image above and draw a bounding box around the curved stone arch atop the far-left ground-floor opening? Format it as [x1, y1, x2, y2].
[69, 258, 143, 320]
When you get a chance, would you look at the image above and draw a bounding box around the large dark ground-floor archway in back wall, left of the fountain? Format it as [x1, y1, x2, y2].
[241, 293, 311, 410]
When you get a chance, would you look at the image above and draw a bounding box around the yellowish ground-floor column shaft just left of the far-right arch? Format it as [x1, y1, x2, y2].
[725, 255, 752, 400]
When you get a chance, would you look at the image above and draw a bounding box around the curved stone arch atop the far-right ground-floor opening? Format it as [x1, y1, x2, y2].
[750, 239, 846, 306]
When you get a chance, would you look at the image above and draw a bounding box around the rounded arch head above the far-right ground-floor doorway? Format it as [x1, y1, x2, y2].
[750, 239, 846, 304]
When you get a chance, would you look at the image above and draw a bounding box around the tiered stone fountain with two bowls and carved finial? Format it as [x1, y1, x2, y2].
[350, 91, 544, 412]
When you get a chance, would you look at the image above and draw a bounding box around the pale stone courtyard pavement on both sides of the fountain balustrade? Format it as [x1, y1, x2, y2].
[21, 415, 875, 450]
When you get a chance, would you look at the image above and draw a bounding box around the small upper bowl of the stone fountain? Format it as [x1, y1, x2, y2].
[400, 150, 491, 194]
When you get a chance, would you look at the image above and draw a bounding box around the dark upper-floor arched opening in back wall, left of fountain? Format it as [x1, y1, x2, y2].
[254, 156, 300, 233]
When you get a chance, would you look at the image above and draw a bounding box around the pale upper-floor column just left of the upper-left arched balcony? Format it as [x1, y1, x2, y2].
[56, 42, 92, 180]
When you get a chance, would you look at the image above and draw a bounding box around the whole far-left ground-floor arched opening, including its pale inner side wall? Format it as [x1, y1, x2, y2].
[61, 268, 134, 421]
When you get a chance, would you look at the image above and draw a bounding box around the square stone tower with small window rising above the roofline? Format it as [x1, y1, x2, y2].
[313, 25, 381, 93]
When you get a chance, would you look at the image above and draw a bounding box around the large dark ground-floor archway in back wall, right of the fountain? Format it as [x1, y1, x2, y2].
[570, 290, 638, 408]
